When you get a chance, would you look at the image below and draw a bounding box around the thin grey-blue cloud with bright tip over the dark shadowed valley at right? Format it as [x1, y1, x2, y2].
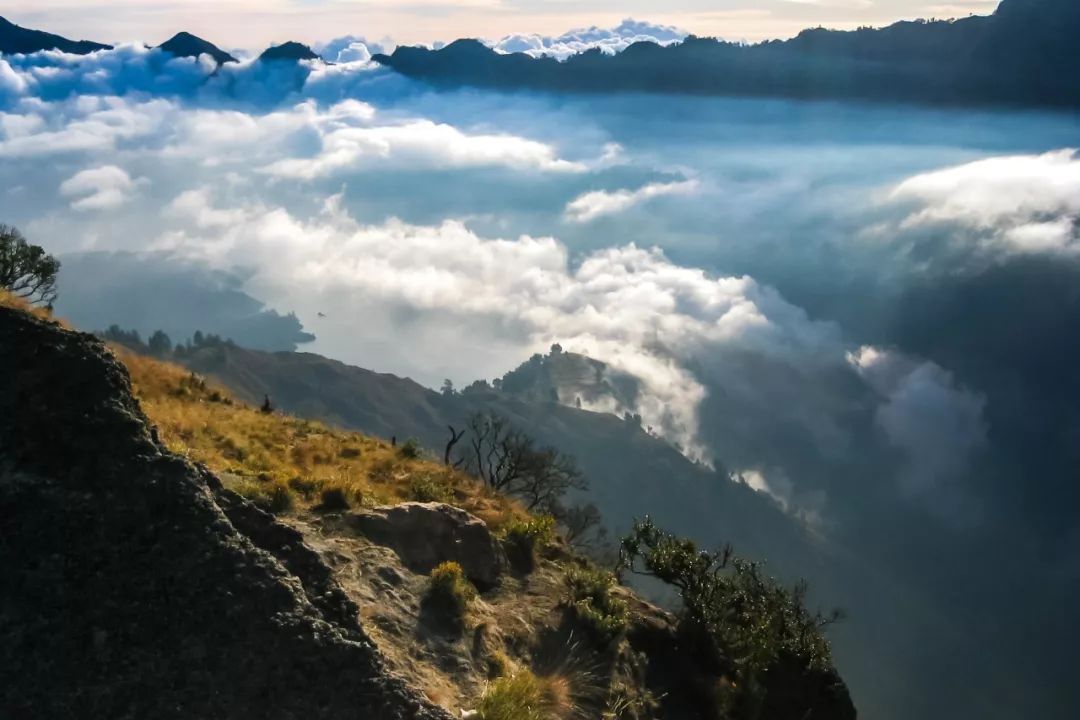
[848, 345, 986, 505]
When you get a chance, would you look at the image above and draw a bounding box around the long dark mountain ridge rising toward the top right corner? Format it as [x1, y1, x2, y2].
[374, 0, 1080, 107]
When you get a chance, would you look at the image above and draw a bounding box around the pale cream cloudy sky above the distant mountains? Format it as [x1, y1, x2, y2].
[0, 0, 998, 49]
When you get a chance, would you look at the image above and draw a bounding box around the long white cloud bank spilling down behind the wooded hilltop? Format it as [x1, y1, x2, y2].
[162, 194, 859, 458]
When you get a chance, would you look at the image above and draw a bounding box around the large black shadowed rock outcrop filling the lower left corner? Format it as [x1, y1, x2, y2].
[0, 308, 448, 720]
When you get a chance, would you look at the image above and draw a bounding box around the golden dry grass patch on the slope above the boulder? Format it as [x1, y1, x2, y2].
[112, 347, 524, 530]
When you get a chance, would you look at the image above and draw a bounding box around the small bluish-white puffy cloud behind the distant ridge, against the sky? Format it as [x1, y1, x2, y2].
[488, 18, 688, 60]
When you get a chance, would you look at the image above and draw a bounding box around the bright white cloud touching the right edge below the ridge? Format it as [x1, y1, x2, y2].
[890, 149, 1080, 255]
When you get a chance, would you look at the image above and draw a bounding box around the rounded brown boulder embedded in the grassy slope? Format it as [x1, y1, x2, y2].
[349, 503, 505, 589]
